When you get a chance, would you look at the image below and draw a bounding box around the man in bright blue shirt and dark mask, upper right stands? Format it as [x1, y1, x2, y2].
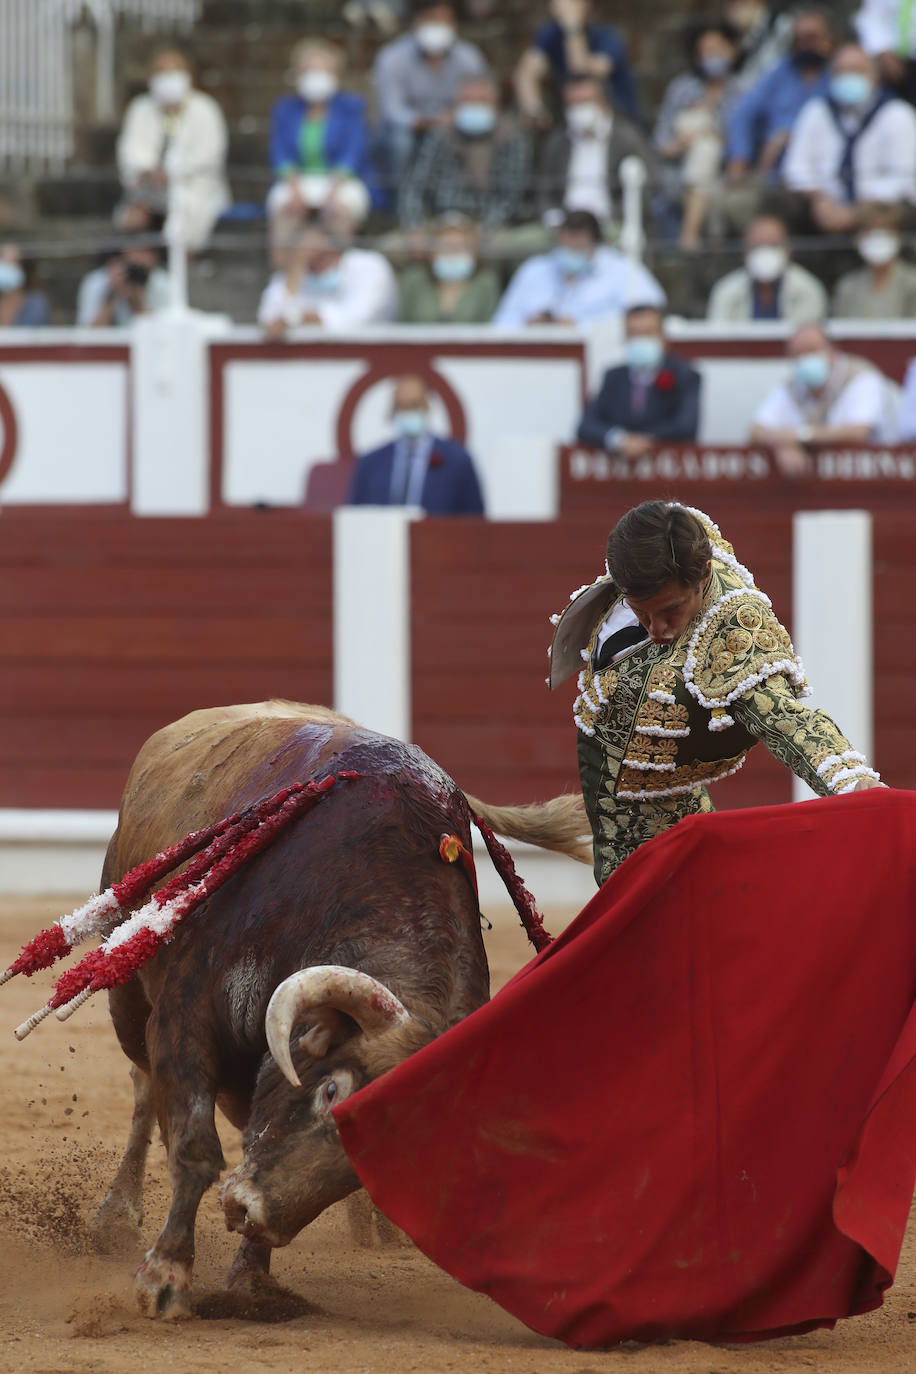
[725, 10, 836, 227]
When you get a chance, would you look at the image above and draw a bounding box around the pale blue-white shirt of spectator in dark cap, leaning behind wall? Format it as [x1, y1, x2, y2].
[493, 245, 665, 328]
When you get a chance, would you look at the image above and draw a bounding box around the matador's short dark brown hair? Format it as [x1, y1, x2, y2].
[607, 502, 713, 600]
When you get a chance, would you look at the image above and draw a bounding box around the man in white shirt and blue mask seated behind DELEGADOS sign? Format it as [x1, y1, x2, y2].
[750, 324, 889, 477]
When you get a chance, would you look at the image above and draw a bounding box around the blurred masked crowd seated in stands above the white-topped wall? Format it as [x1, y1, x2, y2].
[8, 0, 916, 338]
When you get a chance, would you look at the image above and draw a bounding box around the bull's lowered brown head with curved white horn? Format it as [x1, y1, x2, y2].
[222, 965, 430, 1245]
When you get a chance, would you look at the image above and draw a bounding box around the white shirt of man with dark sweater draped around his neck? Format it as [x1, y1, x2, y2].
[783, 96, 916, 203]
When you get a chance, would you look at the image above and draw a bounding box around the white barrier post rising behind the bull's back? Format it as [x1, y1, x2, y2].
[334, 506, 423, 739]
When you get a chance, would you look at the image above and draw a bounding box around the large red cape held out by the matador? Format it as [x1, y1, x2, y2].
[334, 791, 916, 1347]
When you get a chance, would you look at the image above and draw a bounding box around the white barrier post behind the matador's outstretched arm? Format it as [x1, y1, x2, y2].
[792, 511, 873, 801]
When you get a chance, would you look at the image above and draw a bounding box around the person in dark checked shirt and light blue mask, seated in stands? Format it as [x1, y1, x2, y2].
[398, 77, 531, 229]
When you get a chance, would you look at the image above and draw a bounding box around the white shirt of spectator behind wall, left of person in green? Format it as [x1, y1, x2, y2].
[258, 249, 398, 330]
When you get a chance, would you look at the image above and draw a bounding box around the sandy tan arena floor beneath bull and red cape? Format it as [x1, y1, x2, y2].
[0, 896, 916, 1374]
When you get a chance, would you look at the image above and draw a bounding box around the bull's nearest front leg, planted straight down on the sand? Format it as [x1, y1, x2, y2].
[133, 1033, 225, 1320]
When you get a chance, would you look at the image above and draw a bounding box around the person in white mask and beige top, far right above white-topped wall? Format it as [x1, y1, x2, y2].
[832, 205, 916, 320]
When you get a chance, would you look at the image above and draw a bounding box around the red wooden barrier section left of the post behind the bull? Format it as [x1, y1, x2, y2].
[0, 510, 332, 808]
